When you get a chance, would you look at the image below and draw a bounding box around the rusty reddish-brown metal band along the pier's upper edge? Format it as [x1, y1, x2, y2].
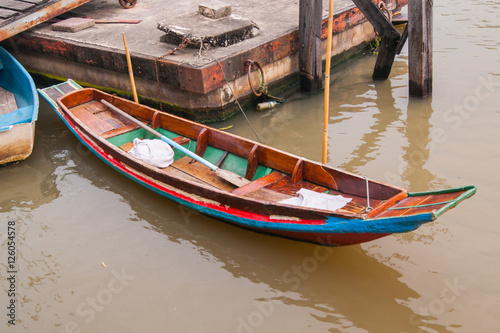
[3, 0, 406, 94]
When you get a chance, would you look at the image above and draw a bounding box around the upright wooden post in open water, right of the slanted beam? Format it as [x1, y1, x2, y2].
[408, 0, 432, 97]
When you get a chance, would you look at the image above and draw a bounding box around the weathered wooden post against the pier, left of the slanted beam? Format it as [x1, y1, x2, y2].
[299, 0, 323, 91]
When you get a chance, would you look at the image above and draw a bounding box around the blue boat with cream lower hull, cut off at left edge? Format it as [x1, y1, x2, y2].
[0, 47, 38, 165]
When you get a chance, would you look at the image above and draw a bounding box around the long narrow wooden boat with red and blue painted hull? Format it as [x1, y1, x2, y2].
[41, 83, 476, 246]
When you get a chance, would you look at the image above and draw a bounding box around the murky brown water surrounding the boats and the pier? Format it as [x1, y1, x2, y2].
[0, 0, 500, 333]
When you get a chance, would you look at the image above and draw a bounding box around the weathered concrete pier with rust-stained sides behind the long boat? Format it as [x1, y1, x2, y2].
[3, 0, 407, 121]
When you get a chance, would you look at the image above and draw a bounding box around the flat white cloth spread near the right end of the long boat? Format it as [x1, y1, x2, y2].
[279, 188, 352, 211]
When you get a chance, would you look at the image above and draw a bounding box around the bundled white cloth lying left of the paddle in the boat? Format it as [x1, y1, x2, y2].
[129, 138, 174, 168]
